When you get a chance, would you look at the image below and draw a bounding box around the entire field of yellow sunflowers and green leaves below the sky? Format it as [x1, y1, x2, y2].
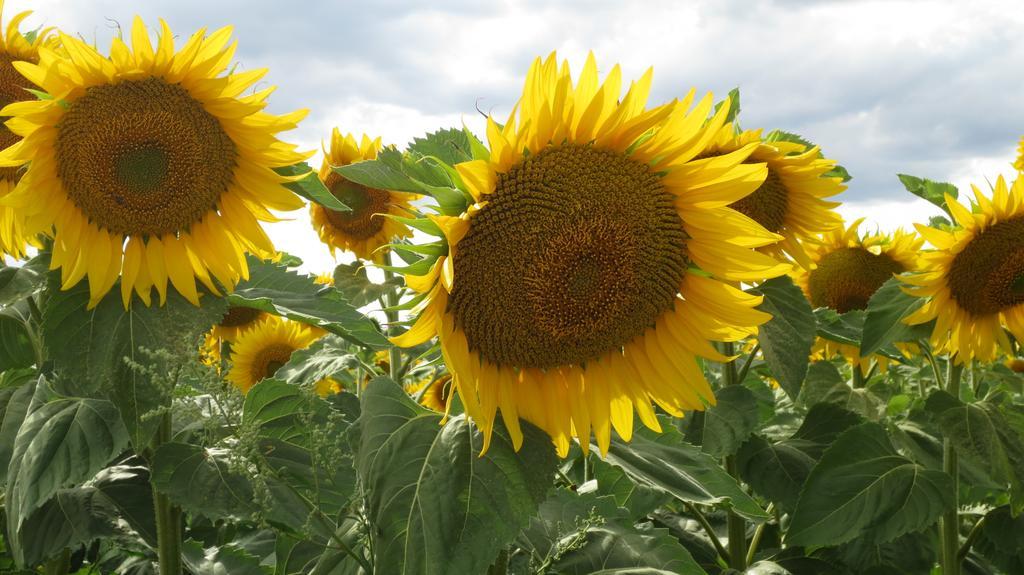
[0, 4, 1024, 575]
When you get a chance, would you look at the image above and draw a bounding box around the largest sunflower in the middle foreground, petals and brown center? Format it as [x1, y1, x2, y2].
[393, 54, 790, 456]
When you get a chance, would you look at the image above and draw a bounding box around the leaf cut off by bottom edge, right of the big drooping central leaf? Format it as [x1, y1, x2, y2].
[520, 489, 705, 575]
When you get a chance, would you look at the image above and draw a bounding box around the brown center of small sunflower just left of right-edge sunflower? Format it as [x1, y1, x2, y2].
[808, 243, 905, 313]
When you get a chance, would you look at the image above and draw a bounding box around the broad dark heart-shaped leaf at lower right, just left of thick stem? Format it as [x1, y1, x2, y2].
[785, 423, 956, 545]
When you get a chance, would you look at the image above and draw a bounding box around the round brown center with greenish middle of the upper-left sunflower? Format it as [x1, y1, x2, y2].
[56, 78, 239, 235]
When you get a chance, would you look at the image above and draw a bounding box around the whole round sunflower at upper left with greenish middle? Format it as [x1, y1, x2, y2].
[0, 17, 307, 307]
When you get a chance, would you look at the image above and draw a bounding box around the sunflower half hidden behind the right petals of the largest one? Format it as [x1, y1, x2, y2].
[701, 124, 846, 267]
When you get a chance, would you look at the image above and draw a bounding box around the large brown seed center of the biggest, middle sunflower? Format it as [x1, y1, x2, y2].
[449, 144, 687, 368]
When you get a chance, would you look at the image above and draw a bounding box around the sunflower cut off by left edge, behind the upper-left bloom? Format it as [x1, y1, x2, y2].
[0, 0, 54, 258]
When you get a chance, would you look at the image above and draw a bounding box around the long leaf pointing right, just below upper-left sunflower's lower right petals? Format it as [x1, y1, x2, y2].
[230, 256, 388, 349]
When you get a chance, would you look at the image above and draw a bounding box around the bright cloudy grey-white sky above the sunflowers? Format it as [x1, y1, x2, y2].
[4, 0, 1024, 268]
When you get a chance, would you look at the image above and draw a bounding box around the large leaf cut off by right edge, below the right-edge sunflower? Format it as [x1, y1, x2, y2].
[927, 391, 1024, 513]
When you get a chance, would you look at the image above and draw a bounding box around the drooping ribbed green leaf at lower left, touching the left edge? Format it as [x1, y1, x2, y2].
[6, 390, 128, 533]
